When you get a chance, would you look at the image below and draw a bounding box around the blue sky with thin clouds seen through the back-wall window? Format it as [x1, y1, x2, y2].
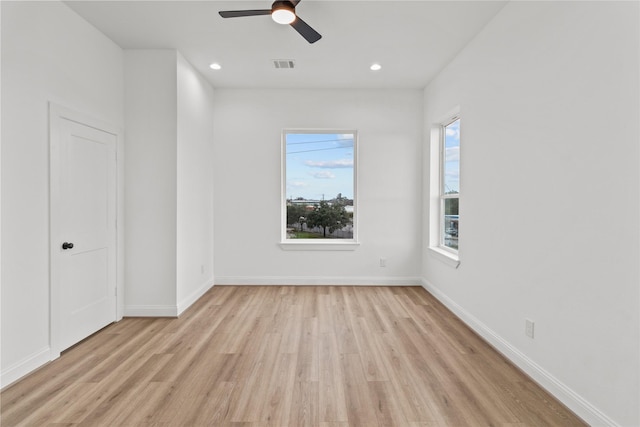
[286, 133, 354, 200]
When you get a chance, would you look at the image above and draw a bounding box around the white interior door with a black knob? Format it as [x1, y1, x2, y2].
[51, 109, 117, 353]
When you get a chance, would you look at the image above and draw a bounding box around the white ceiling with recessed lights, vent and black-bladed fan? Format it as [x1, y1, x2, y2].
[66, 0, 506, 89]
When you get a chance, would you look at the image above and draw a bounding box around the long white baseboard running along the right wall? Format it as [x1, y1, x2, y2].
[422, 279, 619, 427]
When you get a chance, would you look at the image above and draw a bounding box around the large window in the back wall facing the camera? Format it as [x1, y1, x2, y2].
[282, 130, 357, 249]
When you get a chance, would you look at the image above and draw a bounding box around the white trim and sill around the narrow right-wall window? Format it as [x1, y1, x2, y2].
[428, 107, 462, 268]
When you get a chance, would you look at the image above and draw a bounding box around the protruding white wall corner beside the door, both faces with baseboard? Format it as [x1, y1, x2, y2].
[125, 49, 213, 316]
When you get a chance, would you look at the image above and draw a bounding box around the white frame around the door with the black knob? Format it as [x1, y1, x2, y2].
[49, 102, 124, 360]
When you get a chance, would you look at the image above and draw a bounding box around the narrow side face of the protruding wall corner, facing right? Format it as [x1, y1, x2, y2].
[176, 53, 213, 312]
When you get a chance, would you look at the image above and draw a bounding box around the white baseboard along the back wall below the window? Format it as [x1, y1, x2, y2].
[215, 276, 422, 286]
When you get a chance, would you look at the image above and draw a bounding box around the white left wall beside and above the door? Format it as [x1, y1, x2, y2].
[0, 2, 123, 386]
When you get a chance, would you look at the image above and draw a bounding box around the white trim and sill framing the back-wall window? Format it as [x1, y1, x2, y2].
[279, 129, 360, 251]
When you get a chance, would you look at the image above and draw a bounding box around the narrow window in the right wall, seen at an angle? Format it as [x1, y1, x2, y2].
[439, 117, 460, 252]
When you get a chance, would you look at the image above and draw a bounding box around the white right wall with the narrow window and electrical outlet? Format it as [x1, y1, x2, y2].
[423, 2, 640, 426]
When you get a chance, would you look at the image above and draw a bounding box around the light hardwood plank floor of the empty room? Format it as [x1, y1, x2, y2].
[0, 286, 585, 427]
